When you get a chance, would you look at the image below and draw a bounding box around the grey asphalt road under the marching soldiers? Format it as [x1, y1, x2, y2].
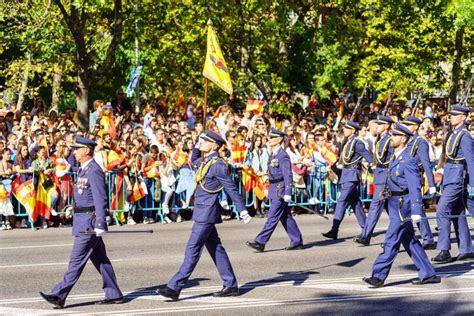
[0, 215, 474, 315]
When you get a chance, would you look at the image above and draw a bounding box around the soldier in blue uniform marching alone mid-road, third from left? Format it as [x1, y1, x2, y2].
[247, 128, 303, 252]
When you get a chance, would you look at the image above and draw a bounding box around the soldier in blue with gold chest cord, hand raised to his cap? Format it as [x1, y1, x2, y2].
[157, 131, 251, 301]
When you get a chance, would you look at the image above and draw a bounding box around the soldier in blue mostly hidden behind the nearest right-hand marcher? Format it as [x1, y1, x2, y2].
[402, 115, 436, 249]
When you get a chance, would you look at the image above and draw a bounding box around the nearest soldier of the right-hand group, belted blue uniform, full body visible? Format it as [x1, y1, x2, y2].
[363, 123, 441, 287]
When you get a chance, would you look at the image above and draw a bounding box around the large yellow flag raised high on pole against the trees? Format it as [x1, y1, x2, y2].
[202, 19, 233, 94]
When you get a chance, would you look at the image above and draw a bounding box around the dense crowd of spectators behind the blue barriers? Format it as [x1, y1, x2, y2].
[0, 87, 466, 230]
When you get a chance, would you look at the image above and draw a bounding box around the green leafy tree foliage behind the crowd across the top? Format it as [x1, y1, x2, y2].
[0, 0, 474, 113]
